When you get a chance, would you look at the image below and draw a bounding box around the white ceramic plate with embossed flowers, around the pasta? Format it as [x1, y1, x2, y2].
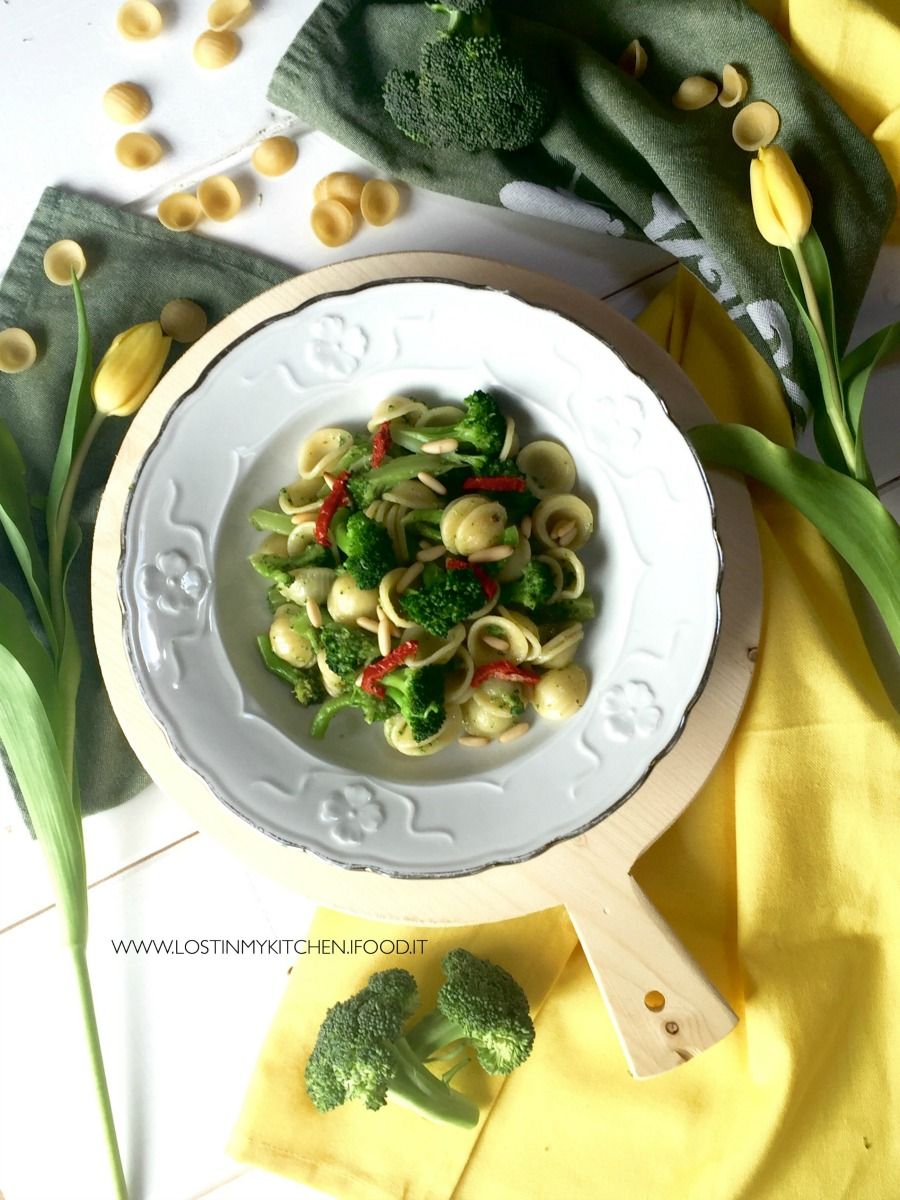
[119, 280, 721, 876]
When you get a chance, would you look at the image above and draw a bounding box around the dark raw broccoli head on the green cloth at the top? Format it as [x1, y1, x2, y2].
[382, 9, 551, 151]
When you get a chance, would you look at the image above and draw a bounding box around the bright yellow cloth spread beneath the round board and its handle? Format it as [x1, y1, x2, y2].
[229, 272, 900, 1200]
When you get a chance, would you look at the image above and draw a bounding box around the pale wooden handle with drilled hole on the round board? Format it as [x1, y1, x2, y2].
[566, 875, 738, 1079]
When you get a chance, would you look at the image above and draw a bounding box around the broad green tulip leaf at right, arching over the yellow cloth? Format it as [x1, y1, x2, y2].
[688, 425, 900, 650]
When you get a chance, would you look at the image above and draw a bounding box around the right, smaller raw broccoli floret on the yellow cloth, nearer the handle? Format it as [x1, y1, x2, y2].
[407, 948, 534, 1075]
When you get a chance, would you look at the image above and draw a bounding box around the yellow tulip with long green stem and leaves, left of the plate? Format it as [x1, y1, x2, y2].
[0, 274, 169, 1200]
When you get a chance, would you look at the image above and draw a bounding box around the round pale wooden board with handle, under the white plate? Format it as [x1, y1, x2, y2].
[92, 253, 762, 1075]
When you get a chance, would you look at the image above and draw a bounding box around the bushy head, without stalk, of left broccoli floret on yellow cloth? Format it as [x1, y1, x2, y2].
[305, 970, 418, 1112]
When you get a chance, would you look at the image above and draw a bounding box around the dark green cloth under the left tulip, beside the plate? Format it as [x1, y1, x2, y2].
[0, 188, 292, 812]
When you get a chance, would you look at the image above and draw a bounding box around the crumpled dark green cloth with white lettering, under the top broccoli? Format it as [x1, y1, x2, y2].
[269, 0, 895, 425]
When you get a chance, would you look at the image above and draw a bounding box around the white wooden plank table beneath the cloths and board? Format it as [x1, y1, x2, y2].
[0, 0, 900, 1200]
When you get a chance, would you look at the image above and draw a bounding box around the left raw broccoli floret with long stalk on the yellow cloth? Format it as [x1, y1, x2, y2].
[305, 968, 478, 1129]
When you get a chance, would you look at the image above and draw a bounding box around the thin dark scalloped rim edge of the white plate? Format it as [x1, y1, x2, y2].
[115, 274, 725, 882]
